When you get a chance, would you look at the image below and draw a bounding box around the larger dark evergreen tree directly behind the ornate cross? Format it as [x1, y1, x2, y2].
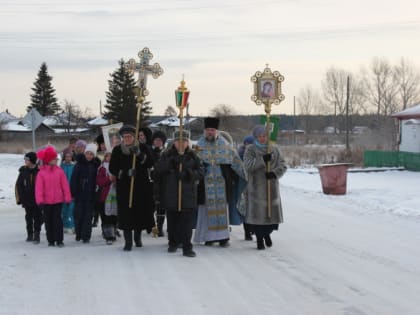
[104, 59, 151, 126]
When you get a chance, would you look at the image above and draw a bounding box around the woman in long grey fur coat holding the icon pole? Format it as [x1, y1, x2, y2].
[244, 125, 287, 249]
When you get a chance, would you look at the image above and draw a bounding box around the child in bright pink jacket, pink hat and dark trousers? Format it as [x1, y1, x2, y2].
[35, 146, 71, 247]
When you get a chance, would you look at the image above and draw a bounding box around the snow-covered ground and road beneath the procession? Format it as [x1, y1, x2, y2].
[0, 154, 420, 315]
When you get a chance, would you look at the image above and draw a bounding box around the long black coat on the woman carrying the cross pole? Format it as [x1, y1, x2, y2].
[109, 144, 154, 230]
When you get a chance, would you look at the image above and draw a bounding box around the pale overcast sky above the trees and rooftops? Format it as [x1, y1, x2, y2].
[0, 0, 420, 115]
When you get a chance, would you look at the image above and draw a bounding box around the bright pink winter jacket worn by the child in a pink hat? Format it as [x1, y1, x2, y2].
[35, 165, 71, 205]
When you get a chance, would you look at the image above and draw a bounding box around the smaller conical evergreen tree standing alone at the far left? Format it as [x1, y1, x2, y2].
[27, 62, 60, 116]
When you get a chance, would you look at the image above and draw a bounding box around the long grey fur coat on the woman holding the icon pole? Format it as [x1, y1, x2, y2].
[244, 144, 287, 225]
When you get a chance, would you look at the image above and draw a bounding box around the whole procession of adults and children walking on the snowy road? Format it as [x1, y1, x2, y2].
[16, 117, 287, 257]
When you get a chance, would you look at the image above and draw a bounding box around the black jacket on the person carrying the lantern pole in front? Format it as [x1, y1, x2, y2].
[153, 146, 204, 211]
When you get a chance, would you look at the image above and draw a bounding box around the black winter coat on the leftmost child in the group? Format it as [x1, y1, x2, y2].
[15, 166, 39, 208]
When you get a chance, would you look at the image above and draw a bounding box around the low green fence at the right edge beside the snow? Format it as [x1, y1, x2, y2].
[363, 151, 420, 171]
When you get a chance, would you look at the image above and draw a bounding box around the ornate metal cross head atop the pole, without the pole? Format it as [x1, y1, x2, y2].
[125, 47, 163, 100]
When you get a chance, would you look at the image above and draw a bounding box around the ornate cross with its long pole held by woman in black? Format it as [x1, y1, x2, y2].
[125, 47, 163, 208]
